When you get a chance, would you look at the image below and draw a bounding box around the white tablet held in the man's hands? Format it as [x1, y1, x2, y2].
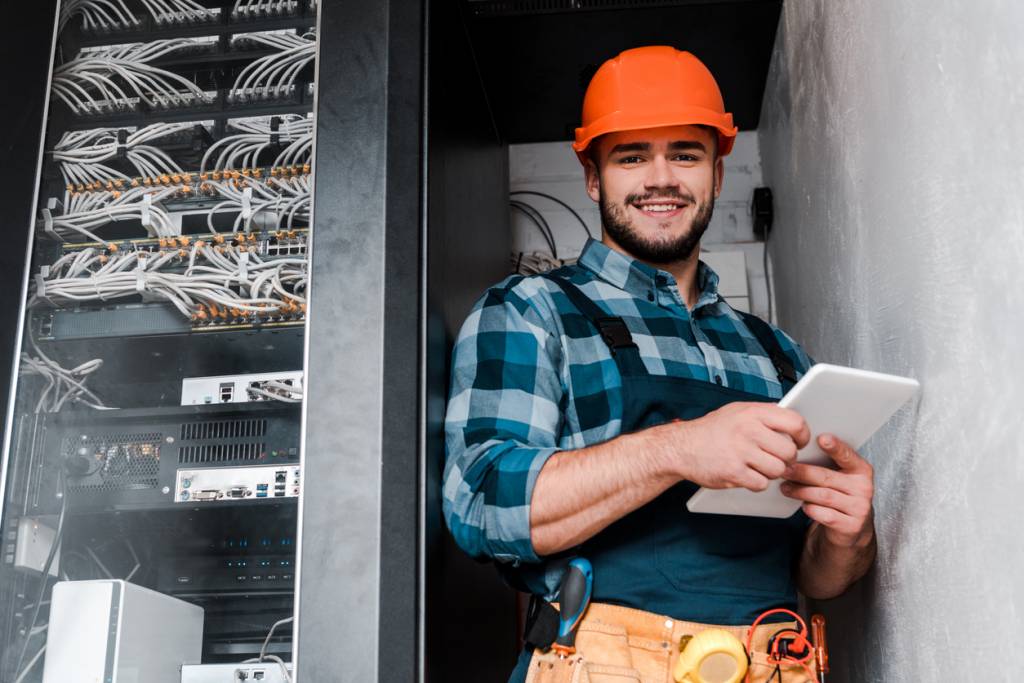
[686, 364, 921, 518]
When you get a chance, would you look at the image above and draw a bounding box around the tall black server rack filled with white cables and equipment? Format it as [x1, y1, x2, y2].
[0, 0, 318, 683]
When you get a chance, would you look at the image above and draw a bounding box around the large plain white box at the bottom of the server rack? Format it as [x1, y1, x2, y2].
[43, 579, 203, 683]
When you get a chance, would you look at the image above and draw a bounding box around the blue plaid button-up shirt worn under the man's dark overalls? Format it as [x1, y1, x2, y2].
[442, 241, 813, 591]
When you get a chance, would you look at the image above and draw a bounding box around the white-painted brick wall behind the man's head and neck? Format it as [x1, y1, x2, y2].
[509, 131, 768, 317]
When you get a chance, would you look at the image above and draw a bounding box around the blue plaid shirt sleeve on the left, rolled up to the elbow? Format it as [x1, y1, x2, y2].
[442, 276, 564, 565]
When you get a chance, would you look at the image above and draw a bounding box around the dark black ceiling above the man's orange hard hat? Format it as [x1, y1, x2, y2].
[464, 0, 782, 143]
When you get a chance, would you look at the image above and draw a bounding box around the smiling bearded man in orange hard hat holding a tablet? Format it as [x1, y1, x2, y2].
[443, 47, 876, 683]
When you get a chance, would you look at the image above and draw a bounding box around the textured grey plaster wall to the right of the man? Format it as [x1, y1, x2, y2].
[761, 0, 1024, 683]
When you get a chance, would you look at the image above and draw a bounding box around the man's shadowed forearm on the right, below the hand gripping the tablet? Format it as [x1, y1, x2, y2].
[797, 522, 878, 600]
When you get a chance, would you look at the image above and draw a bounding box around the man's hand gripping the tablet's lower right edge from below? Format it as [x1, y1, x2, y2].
[781, 434, 874, 548]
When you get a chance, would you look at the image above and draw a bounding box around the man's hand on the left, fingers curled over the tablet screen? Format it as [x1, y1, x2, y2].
[663, 402, 811, 490]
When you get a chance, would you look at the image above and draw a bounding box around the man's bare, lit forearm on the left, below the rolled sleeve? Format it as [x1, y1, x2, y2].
[529, 425, 679, 556]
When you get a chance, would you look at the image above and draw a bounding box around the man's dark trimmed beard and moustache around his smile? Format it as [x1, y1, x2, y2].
[600, 190, 715, 265]
